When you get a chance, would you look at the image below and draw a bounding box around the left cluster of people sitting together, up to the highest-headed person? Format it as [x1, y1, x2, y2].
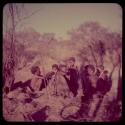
[11, 57, 79, 97]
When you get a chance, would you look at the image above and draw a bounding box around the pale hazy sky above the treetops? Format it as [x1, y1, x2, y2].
[3, 3, 122, 39]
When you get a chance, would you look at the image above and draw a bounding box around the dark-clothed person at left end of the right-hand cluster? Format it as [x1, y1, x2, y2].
[79, 65, 97, 116]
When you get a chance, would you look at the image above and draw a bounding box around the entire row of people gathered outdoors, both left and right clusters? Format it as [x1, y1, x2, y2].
[3, 57, 111, 120]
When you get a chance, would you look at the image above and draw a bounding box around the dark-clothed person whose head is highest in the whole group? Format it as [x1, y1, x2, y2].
[67, 57, 79, 97]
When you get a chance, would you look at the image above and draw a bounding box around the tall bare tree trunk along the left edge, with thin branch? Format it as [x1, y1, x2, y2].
[3, 3, 42, 92]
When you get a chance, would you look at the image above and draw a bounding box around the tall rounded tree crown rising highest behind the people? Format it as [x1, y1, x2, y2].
[68, 22, 107, 66]
